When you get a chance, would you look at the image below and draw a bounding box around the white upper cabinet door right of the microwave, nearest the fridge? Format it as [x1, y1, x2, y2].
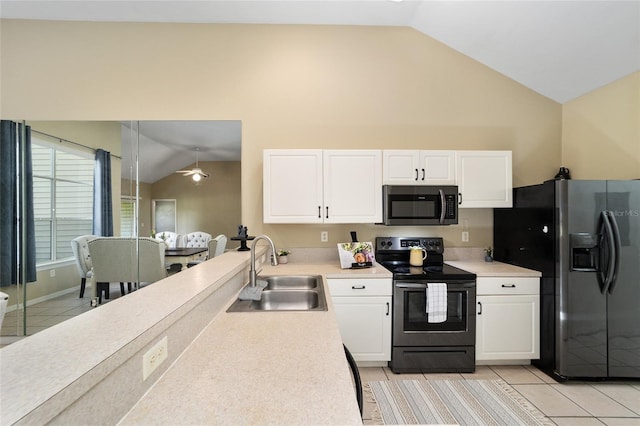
[456, 151, 513, 208]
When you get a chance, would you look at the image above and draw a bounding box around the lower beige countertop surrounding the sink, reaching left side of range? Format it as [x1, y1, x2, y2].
[122, 263, 382, 424]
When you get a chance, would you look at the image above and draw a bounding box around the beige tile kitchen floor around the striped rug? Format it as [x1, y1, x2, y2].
[359, 365, 640, 426]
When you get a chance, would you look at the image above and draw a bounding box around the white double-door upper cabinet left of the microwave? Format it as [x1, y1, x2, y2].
[263, 149, 382, 223]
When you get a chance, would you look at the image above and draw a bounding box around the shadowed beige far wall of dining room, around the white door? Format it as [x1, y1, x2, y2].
[150, 161, 242, 243]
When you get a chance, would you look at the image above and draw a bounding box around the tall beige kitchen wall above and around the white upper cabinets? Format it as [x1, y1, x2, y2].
[0, 21, 562, 247]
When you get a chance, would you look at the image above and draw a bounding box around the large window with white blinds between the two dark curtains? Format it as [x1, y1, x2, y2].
[31, 134, 95, 264]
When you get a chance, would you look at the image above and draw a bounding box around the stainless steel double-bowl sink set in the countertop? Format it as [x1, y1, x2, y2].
[227, 275, 327, 312]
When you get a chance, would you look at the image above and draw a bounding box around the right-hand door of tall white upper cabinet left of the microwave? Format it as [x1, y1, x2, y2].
[322, 150, 382, 223]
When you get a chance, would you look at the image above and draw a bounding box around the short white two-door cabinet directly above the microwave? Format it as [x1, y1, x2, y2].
[382, 150, 456, 185]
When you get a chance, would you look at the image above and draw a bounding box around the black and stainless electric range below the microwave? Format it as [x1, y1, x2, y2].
[376, 237, 476, 373]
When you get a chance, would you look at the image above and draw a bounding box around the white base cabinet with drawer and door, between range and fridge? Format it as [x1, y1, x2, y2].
[476, 277, 540, 362]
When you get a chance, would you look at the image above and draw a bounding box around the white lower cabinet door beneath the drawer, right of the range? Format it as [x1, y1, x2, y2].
[476, 295, 540, 361]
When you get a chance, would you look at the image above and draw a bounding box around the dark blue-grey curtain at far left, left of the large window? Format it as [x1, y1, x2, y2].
[0, 120, 36, 287]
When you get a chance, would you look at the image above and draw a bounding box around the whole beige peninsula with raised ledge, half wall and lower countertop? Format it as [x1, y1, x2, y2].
[0, 250, 380, 424]
